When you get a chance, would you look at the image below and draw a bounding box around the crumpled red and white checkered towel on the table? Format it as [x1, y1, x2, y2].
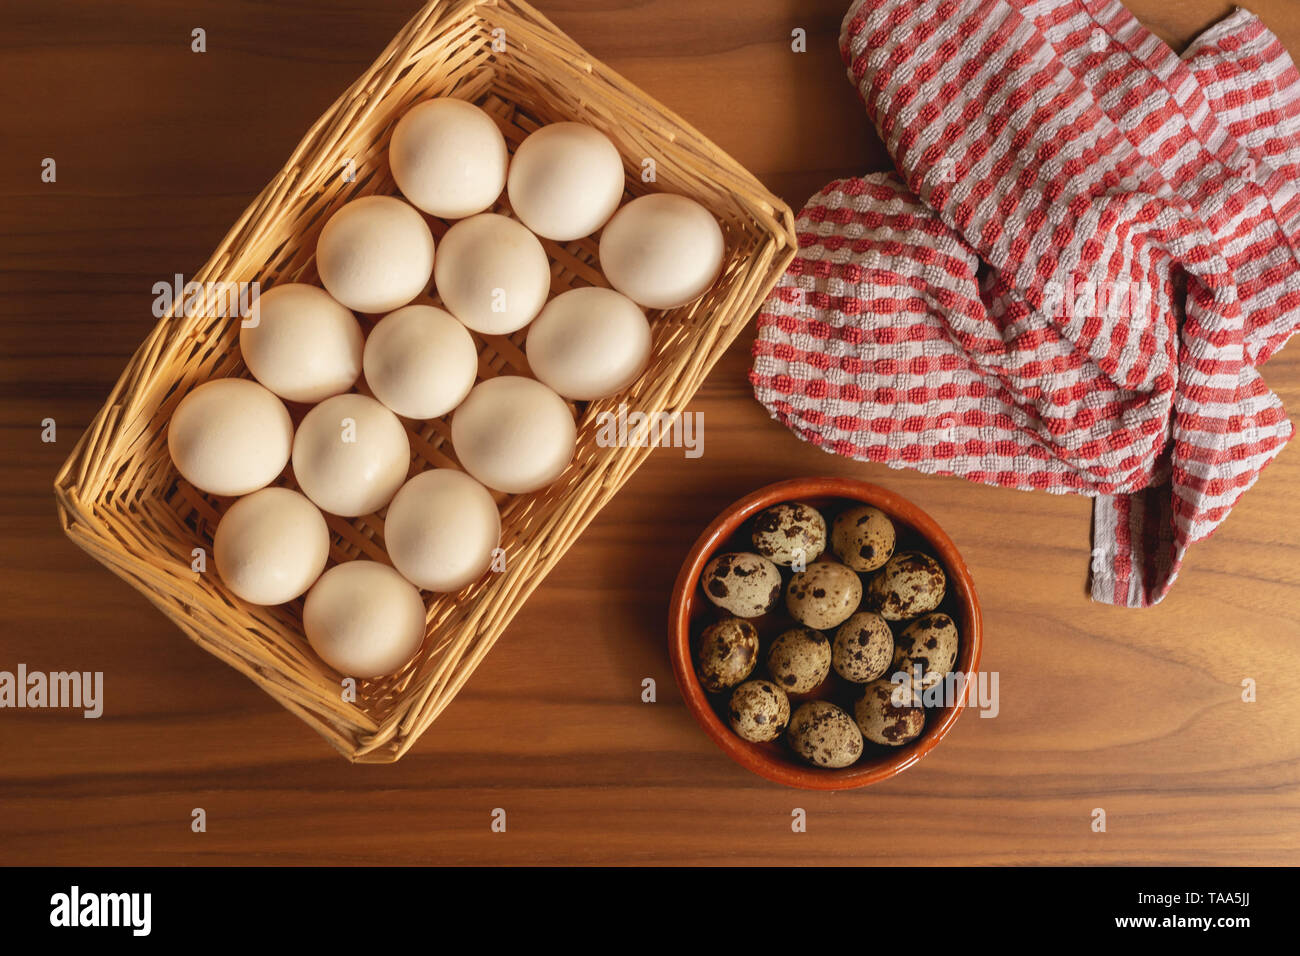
[750, 0, 1300, 606]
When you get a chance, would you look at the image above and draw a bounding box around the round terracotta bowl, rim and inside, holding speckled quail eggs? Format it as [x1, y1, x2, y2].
[668, 477, 982, 790]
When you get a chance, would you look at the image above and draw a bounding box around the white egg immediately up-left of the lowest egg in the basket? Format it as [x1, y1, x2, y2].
[212, 488, 329, 605]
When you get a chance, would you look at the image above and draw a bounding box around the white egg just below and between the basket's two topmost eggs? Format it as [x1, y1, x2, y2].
[434, 212, 551, 336]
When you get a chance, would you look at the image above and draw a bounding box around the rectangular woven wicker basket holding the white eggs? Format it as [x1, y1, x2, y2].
[55, 0, 794, 762]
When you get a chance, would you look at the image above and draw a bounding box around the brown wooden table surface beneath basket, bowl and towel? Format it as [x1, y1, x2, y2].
[0, 0, 1300, 864]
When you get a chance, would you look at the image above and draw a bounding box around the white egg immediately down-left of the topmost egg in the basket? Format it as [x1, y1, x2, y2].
[316, 196, 434, 313]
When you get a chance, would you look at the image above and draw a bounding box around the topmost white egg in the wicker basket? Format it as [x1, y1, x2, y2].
[389, 96, 510, 219]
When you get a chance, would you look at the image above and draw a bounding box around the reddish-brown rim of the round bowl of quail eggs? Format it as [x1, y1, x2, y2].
[668, 477, 983, 790]
